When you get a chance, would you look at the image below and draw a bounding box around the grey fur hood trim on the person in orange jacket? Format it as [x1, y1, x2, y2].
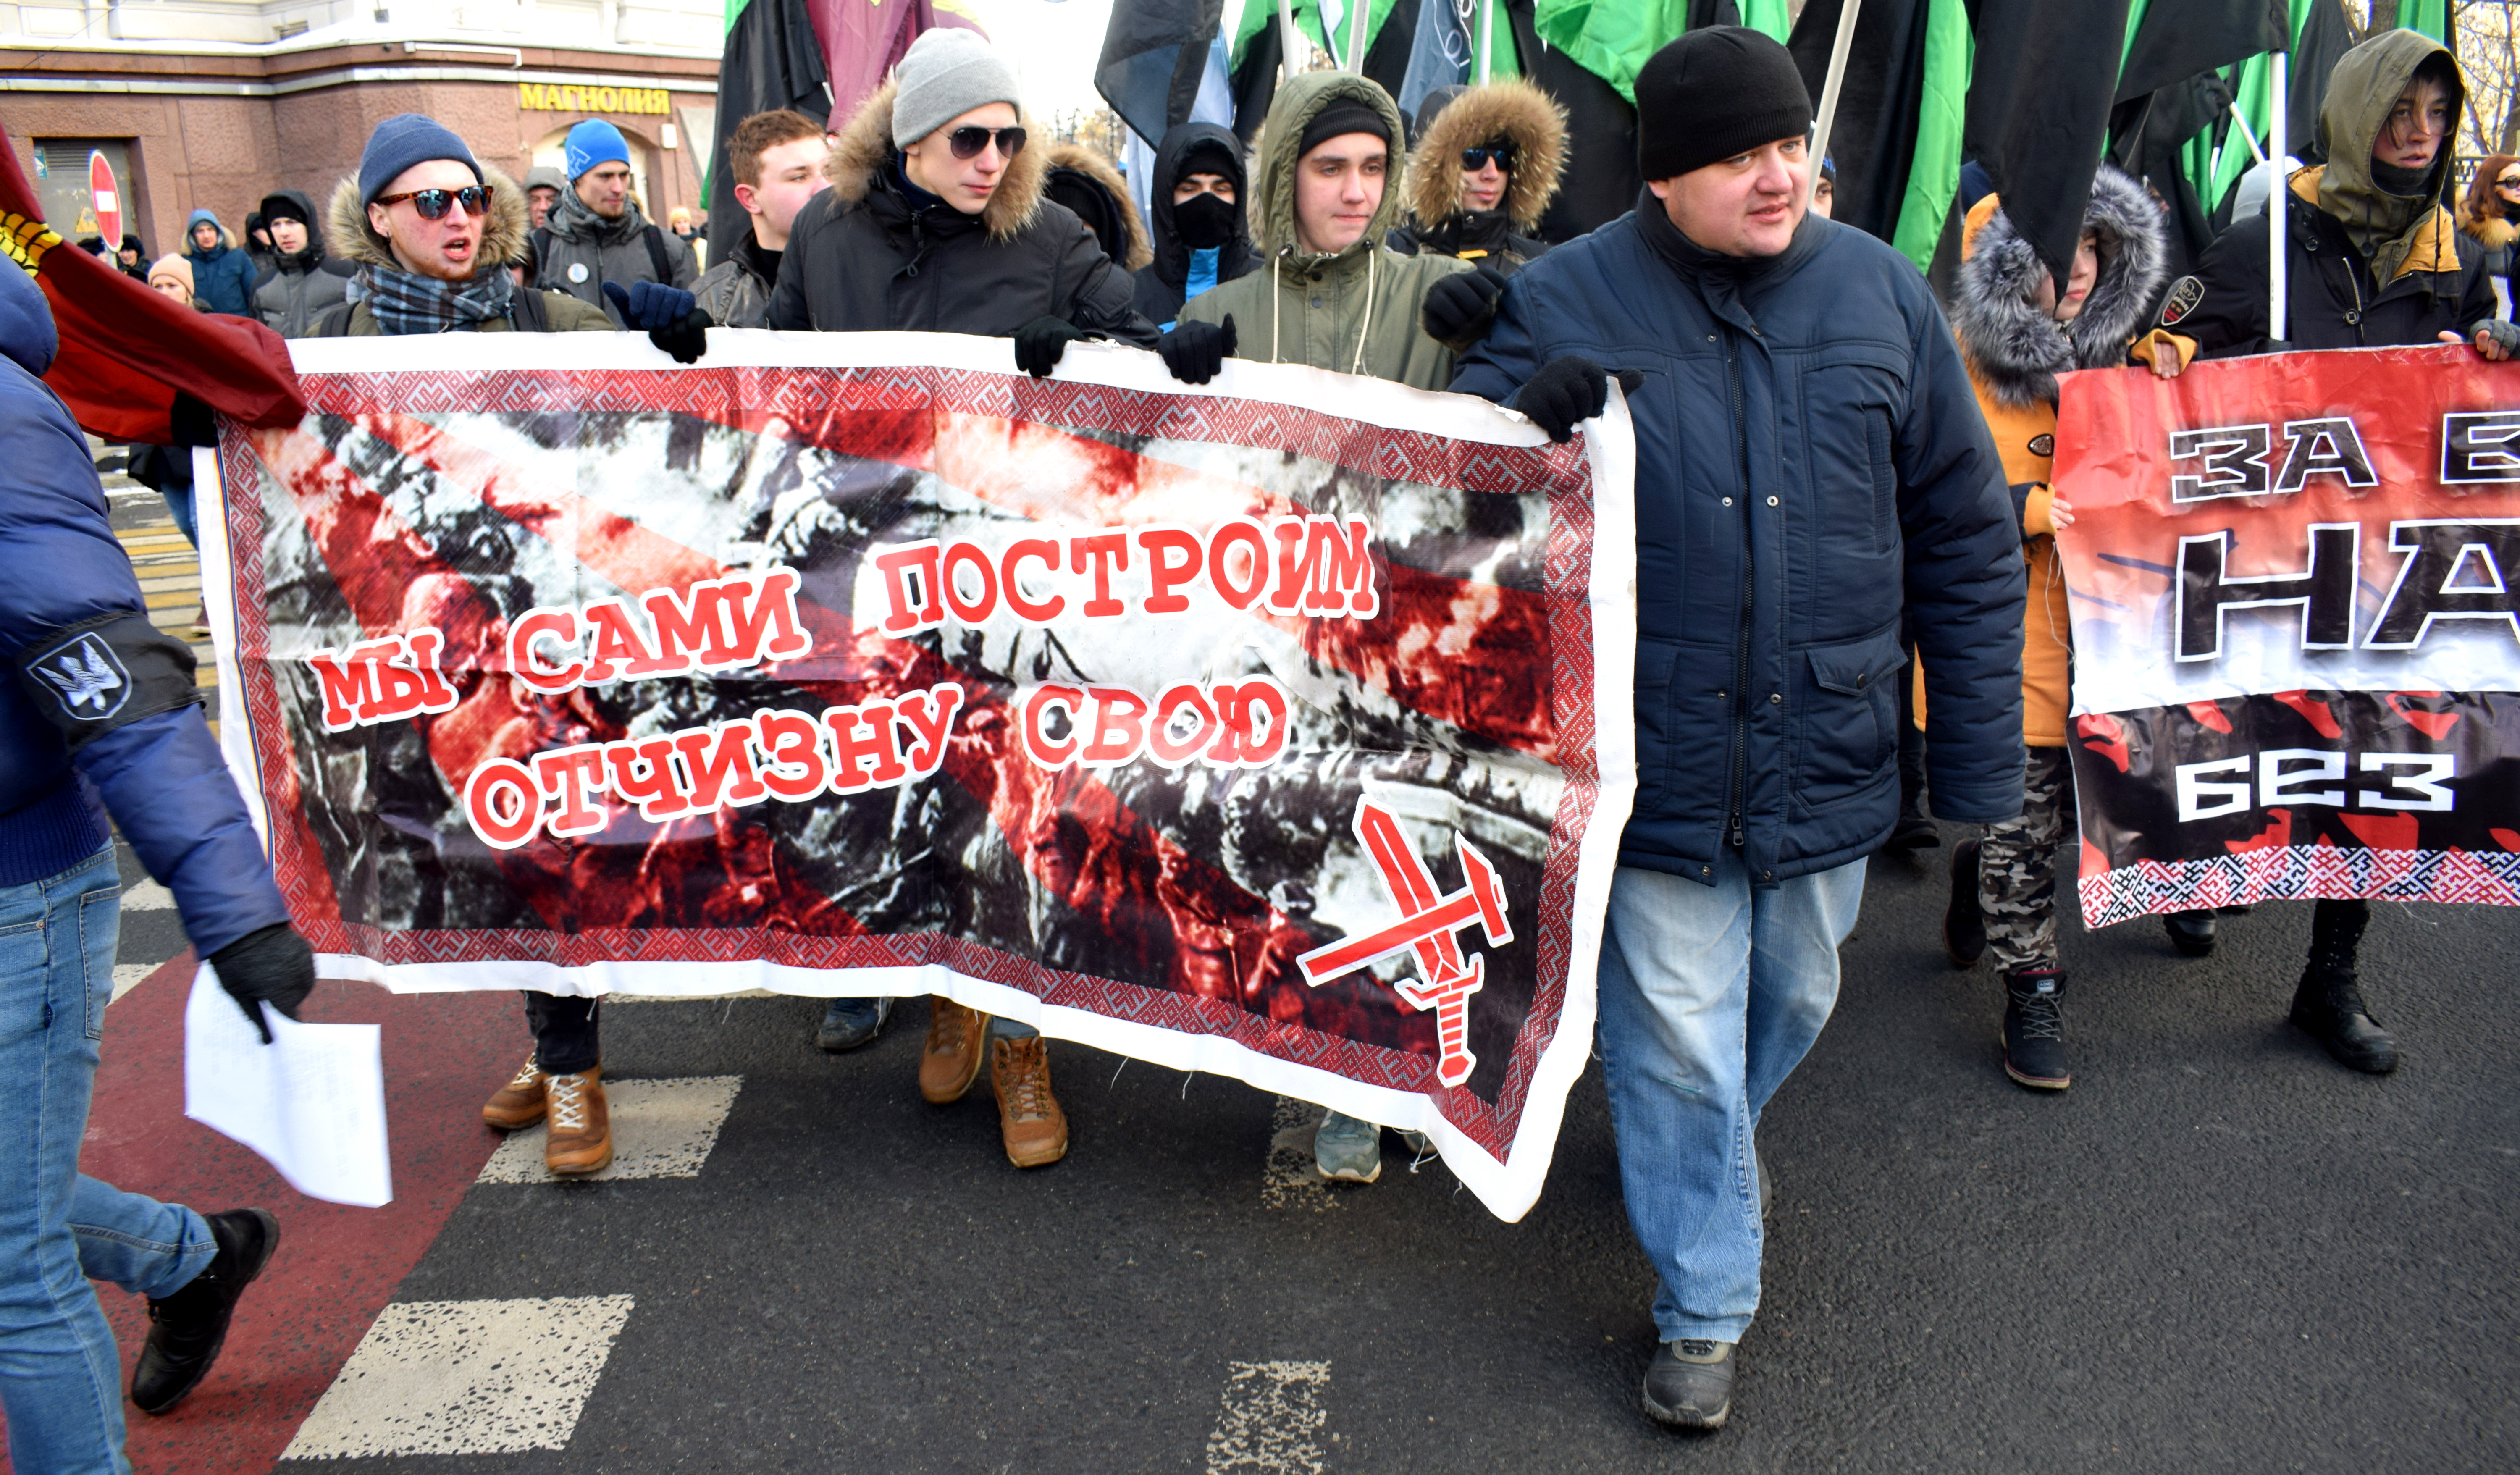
[1950, 164, 2167, 409]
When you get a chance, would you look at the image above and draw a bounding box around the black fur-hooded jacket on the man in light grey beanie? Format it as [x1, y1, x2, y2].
[769, 83, 1159, 348]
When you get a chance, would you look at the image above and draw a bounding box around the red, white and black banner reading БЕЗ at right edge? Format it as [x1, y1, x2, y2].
[2056, 348, 2520, 925]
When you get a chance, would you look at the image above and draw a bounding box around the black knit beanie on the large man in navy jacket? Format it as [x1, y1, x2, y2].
[1635, 25, 1812, 179]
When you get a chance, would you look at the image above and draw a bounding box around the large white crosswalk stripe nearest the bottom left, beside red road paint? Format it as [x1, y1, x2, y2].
[280, 1296, 635, 1460]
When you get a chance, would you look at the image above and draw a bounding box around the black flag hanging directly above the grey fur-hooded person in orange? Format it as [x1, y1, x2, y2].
[1976, 0, 2137, 296]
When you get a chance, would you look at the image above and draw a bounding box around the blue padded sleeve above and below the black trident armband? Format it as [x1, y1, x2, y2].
[0, 365, 290, 955]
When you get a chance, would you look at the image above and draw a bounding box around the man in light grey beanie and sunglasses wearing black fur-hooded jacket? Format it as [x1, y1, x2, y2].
[769, 30, 1159, 391]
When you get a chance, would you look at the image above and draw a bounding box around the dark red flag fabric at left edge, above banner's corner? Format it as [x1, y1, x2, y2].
[0, 129, 307, 444]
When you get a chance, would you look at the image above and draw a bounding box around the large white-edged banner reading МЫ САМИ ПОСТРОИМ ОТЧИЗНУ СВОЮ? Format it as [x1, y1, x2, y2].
[204, 333, 1635, 1218]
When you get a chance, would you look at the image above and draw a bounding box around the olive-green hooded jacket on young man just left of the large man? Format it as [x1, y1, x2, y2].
[1182, 71, 1474, 388]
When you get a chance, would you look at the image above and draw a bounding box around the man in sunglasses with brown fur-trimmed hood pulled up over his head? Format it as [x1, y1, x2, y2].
[1391, 78, 1567, 277]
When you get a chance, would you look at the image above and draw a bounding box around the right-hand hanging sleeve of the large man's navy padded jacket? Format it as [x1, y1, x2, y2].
[1898, 282, 2029, 824]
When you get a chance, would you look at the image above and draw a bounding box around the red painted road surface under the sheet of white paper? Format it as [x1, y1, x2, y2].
[0, 953, 532, 1475]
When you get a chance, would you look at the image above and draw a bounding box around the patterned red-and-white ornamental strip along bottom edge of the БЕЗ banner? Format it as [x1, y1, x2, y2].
[2076, 845, 2520, 928]
